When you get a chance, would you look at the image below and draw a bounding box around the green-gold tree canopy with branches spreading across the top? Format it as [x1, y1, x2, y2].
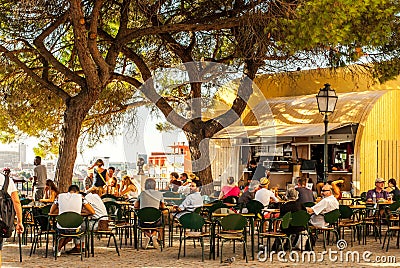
[0, 0, 400, 166]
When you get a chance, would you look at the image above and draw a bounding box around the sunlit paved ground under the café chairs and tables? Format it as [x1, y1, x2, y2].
[2, 229, 400, 268]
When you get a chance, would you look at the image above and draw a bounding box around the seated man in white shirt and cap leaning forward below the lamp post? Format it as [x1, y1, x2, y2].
[306, 184, 339, 228]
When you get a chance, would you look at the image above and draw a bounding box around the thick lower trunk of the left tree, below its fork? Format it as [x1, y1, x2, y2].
[55, 99, 92, 192]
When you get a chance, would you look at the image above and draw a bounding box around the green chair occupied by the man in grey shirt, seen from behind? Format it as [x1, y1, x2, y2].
[136, 207, 165, 251]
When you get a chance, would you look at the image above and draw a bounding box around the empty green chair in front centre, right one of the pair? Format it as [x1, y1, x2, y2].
[217, 214, 247, 263]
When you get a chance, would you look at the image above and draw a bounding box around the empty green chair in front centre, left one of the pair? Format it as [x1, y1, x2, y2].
[178, 212, 210, 261]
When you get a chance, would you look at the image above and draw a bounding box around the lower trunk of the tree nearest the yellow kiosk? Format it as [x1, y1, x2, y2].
[185, 131, 214, 195]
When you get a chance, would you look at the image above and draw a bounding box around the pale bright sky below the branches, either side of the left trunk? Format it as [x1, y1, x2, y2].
[0, 108, 187, 164]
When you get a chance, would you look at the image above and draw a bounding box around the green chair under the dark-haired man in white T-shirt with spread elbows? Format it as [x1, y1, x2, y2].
[54, 212, 85, 261]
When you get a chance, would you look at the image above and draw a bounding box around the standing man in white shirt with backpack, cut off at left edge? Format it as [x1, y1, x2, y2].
[0, 168, 24, 267]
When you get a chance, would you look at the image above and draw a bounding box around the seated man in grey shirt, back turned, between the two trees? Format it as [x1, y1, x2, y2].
[135, 178, 165, 249]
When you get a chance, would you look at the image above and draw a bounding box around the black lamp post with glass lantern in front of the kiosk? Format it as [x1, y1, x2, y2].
[316, 84, 338, 183]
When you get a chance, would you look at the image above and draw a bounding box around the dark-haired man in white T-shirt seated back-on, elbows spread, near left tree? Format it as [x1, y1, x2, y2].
[50, 185, 95, 256]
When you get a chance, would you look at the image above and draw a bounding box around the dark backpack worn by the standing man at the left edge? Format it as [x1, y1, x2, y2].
[0, 175, 15, 238]
